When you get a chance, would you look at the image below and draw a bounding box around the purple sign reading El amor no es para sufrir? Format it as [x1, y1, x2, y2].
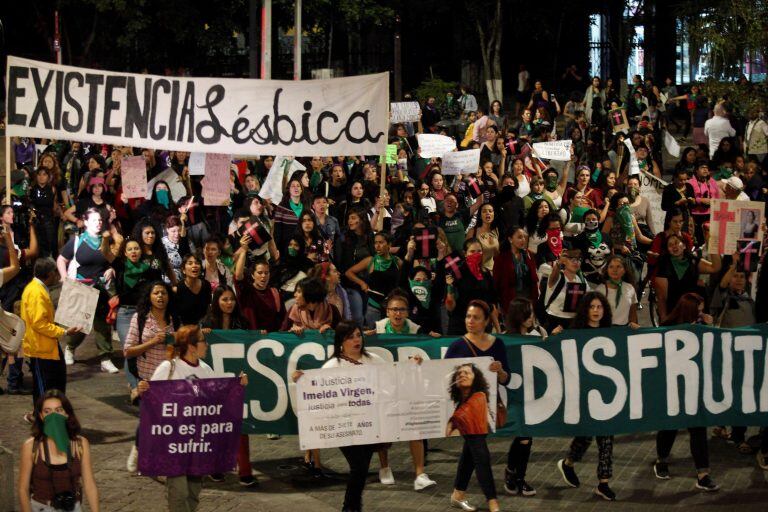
[139, 378, 243, 477]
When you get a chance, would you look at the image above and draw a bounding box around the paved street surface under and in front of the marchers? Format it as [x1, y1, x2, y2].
[0, 330, 768, 512]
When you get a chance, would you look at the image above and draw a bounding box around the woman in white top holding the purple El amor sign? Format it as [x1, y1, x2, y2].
[139, 325, 248, 512]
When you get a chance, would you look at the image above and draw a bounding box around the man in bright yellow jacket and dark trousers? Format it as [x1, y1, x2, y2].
[21, 258, 80, 403]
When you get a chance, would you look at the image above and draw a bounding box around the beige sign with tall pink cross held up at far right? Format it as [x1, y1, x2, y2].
[709, 199, 765, 254]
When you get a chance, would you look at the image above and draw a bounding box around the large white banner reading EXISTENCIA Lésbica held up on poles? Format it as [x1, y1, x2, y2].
[6, 57, 389, 156]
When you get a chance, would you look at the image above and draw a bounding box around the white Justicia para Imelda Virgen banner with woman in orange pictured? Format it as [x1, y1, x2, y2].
[296, 357, 498, 450]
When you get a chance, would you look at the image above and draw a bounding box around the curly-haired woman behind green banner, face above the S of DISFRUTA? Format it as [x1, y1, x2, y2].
[557, 292, 616, 501]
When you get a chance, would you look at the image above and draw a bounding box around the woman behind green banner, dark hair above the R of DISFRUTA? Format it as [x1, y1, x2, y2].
[653, 293, 720, 492]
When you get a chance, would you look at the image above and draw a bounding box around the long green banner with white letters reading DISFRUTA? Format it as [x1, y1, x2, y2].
[208, 324, 768, 437]
